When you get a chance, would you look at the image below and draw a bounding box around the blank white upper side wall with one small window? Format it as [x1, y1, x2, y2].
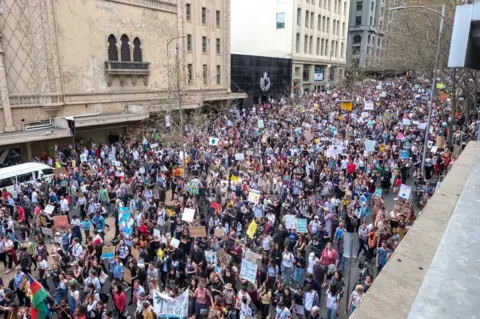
[230, 0, 296, 58]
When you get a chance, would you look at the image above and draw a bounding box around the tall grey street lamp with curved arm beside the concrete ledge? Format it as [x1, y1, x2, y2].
[389, 4, 446, 176]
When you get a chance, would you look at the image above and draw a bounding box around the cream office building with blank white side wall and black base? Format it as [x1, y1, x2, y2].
[231, 0, 349, 102]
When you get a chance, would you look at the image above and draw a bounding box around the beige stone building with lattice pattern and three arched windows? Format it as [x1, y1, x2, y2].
[0, 0, 245, 165]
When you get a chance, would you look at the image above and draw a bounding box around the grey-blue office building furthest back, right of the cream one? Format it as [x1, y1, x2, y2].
[347, 0, 388, 68]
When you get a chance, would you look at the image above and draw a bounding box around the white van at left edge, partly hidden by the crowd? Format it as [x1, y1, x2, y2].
[0, 163, 53, 197]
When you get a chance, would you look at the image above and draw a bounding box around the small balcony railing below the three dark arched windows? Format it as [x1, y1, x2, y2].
[105, 61, 150, 86]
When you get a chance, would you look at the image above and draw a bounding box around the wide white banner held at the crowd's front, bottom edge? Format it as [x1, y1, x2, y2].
[152, 289, 189, 318]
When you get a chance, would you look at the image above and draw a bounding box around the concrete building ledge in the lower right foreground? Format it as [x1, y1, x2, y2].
[346, 141, 480, 319]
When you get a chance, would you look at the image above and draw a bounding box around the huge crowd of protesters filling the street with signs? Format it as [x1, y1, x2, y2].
[0, 77, 476, 319]
